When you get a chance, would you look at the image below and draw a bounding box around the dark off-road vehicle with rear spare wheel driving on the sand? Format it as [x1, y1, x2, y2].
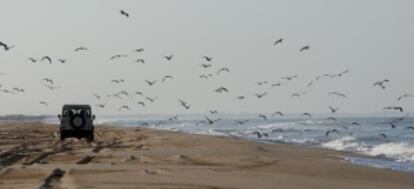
[58, 104, 95, 142]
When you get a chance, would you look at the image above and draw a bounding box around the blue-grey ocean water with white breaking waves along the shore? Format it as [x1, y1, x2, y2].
[44, 114, 414, 173]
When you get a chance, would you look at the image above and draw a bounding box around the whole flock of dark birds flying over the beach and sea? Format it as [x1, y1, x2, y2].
[0, 10, 414, 142]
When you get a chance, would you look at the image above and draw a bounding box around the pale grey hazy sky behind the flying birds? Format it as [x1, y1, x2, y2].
[0, 0, 414, 114]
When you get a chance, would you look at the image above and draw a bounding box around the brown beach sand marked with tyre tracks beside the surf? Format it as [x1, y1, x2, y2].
[0, 123, 414, 189]
